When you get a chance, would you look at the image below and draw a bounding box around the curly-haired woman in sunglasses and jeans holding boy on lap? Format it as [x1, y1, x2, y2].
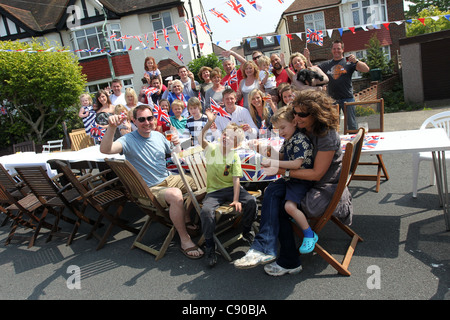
[234, 90, 353, 276]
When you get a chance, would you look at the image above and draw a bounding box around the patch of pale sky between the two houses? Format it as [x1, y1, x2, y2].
[202, 0, 294, 49]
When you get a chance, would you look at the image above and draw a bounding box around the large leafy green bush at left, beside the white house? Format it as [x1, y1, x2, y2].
[0, 39, 86, 146]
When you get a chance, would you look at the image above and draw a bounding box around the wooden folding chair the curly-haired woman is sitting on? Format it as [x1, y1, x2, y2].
[292, 128, 364, 276]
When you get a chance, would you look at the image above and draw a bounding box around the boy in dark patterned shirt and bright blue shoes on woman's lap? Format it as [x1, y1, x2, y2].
[261, 106, 318, 254]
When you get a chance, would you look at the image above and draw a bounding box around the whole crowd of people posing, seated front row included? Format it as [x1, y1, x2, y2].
[79, 41, 369, 276]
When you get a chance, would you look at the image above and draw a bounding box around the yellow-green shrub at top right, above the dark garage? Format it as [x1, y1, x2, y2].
[406, 6, 450, 37]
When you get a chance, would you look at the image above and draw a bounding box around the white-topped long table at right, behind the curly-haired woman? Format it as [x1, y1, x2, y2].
[341, 128, 450, 231]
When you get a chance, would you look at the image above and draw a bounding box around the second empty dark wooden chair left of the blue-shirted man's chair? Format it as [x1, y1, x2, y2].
[15, 166, 89, 245]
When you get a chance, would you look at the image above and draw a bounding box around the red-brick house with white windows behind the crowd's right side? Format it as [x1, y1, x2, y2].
[276, 0, 406, 76]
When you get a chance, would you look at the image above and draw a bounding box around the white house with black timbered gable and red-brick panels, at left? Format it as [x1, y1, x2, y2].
[0, 0, 213, 93]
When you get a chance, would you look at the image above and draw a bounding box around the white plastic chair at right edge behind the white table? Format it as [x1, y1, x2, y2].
[413, 111, 450, 198]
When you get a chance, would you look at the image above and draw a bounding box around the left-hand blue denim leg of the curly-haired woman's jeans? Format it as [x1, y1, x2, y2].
[251, 180, 286, 256]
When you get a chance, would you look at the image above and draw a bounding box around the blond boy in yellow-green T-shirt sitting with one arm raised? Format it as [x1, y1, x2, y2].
[199, 110, 257, 267]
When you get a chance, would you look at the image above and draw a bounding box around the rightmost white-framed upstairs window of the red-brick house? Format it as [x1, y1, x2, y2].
[351, 0, 387, 26]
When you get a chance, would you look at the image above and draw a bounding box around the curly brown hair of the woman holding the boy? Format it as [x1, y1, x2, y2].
[292, 90, 339, 137]
